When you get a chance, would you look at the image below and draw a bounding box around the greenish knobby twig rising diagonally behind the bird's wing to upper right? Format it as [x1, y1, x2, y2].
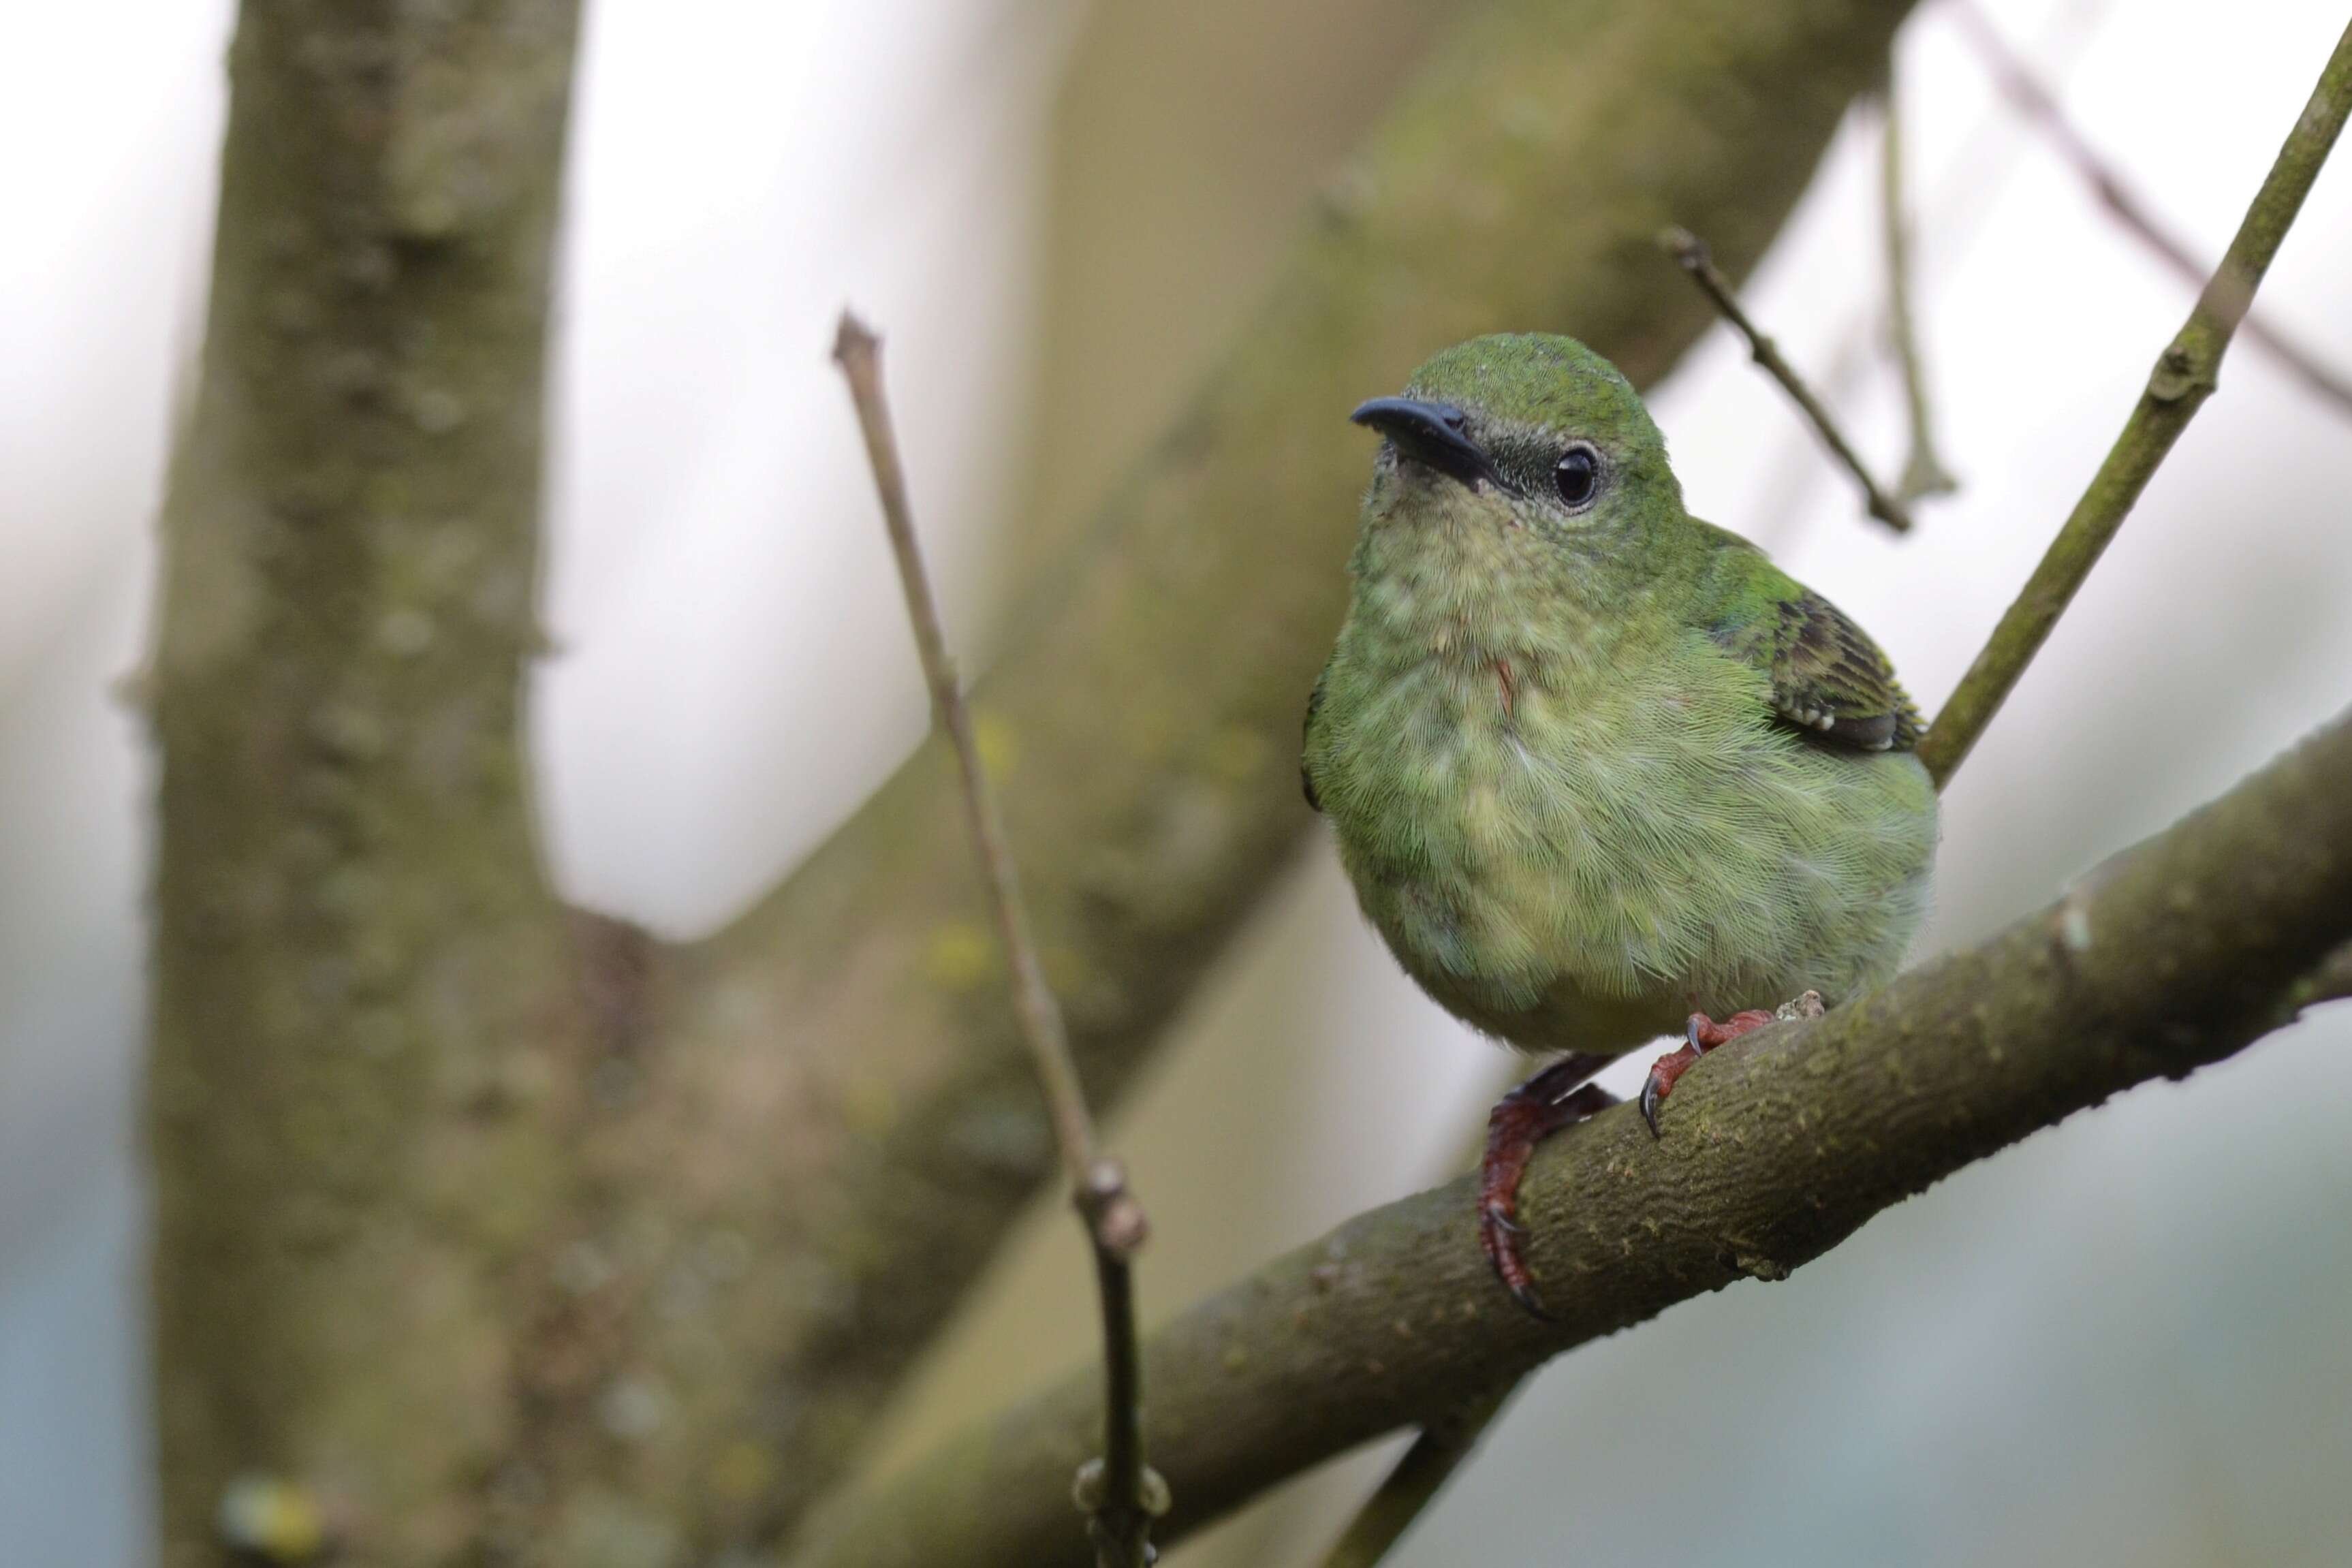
[1919, 15, 2352, 785]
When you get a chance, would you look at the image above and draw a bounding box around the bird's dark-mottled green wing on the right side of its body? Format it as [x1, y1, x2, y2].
[1705, 533, 1926, 752]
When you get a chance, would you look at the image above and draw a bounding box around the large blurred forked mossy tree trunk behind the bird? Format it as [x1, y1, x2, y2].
[151, 0, 1907, 1566]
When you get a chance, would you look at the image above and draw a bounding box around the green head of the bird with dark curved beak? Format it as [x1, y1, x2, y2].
[1352, 332, 1682, 548]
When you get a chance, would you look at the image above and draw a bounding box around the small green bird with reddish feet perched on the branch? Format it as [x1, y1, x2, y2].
[1301, 334, 1936, 1314]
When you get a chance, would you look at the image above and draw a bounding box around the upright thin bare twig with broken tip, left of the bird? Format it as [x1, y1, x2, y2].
[832, 311, 1169, 1568]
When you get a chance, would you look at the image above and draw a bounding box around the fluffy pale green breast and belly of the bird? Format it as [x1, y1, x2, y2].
[1308, 625, 1936, 1048]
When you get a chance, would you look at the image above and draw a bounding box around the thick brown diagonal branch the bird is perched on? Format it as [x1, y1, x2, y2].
[790, 719, 2352, 1568]
